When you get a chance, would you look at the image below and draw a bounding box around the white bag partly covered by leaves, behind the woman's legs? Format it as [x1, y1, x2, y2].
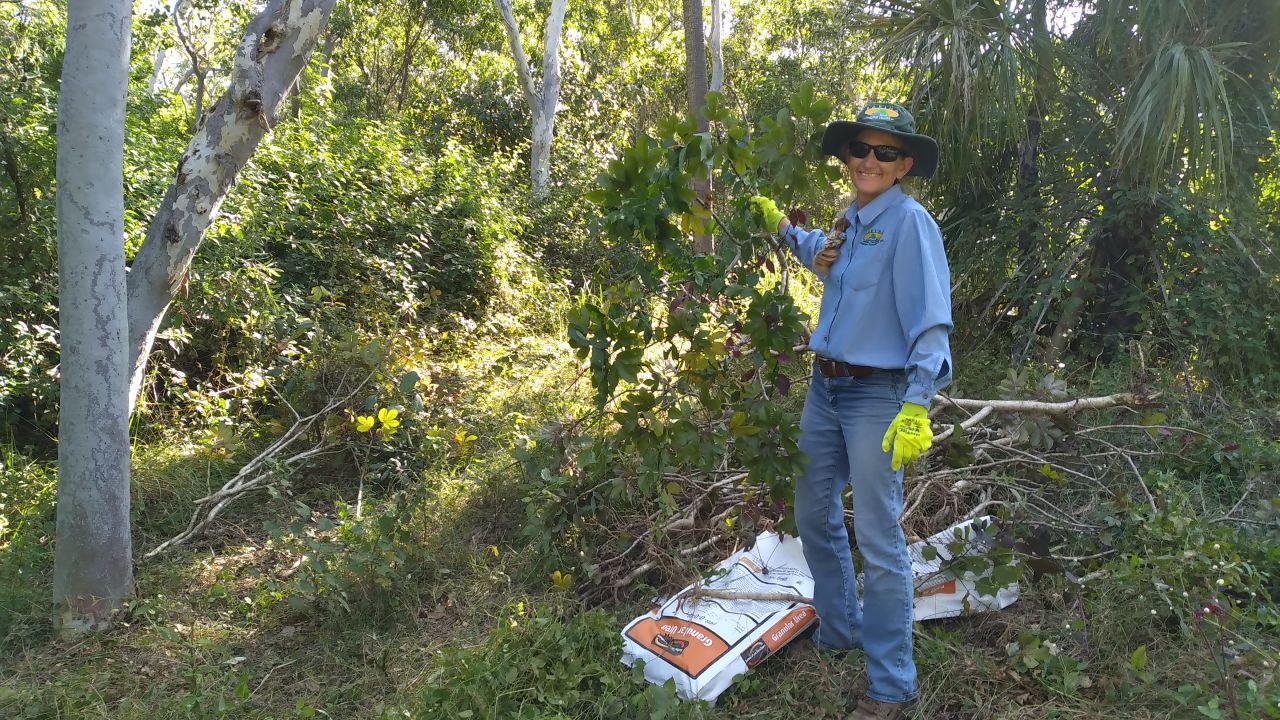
[908, 516, 1018, 620]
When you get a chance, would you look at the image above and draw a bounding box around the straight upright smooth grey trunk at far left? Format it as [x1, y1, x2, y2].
[54, 0, 133, 635]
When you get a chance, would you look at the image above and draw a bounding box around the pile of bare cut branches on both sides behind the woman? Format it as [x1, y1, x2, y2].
[589, 393, 1177, 597]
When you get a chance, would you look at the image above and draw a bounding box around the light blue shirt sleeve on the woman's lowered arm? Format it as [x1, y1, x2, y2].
[893, 209, 952, 407]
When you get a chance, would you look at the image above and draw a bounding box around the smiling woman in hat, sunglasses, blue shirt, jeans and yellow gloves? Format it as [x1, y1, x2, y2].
[751, 102, 951, 720]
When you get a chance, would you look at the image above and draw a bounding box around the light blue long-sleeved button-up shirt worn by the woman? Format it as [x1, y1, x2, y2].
[782, 184, 952, 407]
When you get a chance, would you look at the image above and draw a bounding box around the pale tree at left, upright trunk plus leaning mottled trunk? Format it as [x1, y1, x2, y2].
[54, 0, 335, 635]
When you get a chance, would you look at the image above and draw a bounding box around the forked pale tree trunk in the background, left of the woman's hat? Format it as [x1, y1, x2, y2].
[493, 0, 567, 200]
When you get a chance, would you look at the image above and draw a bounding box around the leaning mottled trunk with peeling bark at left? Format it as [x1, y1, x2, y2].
[128, 0, 335, 411]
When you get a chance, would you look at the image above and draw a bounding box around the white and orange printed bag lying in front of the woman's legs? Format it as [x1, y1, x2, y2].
[622, 533, 818, 702]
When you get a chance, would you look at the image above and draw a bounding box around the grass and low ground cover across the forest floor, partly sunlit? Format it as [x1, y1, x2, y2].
[0, 299, 1280, 720]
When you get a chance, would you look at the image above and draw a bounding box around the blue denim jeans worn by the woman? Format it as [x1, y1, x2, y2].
[795, 366, 919, 702]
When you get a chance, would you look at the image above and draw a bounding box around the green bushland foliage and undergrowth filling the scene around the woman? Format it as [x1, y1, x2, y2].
[0, 0, 1280, 720]
